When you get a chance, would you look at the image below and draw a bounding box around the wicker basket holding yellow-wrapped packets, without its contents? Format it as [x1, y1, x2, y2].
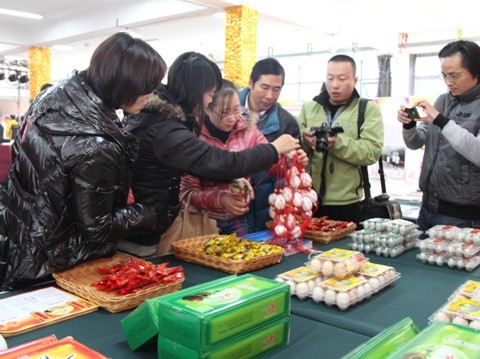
[172, 234, 283, 274]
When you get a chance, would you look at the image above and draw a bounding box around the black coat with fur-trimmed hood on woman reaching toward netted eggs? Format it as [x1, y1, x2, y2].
[126, 88, 278, 245]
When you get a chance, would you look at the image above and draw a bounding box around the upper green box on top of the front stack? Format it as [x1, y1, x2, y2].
[158, 274, 290, 352]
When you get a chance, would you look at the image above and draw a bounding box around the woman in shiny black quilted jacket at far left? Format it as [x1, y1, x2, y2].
[0, 33, 167, 290]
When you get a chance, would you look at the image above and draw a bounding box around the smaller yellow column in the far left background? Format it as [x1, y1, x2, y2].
[28, 47, 51, 100]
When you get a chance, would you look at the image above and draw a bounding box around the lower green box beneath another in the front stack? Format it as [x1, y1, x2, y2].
[158, 317, 290, 359]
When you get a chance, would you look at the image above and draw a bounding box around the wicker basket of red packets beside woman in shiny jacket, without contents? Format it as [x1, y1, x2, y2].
[53, 254, 184, 313]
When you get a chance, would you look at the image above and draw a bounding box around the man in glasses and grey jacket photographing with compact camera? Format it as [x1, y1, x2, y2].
[398, 40, 480, 231]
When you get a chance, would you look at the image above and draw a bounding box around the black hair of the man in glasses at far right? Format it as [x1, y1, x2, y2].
[438, 40, 480, 81]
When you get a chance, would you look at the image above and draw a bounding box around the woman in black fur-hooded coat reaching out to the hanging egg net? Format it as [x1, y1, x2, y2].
[121, 52, 300, 256]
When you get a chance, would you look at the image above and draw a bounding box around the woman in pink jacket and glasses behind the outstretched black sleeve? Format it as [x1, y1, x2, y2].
[180, 80, 307, 235]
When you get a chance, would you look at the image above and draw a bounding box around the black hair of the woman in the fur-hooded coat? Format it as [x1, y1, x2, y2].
[167, 51, 222, 118]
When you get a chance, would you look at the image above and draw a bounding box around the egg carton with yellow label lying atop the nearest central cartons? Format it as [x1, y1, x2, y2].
[306, 248, 368, 279]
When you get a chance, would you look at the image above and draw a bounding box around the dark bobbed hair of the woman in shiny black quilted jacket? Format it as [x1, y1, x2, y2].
[87, 32, 167, 109]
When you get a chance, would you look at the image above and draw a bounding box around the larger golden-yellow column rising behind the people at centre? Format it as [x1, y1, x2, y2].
[224, 5, 258, 87]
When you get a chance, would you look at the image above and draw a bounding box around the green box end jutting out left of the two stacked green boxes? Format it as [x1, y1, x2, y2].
[120, 297, 160, 350]
